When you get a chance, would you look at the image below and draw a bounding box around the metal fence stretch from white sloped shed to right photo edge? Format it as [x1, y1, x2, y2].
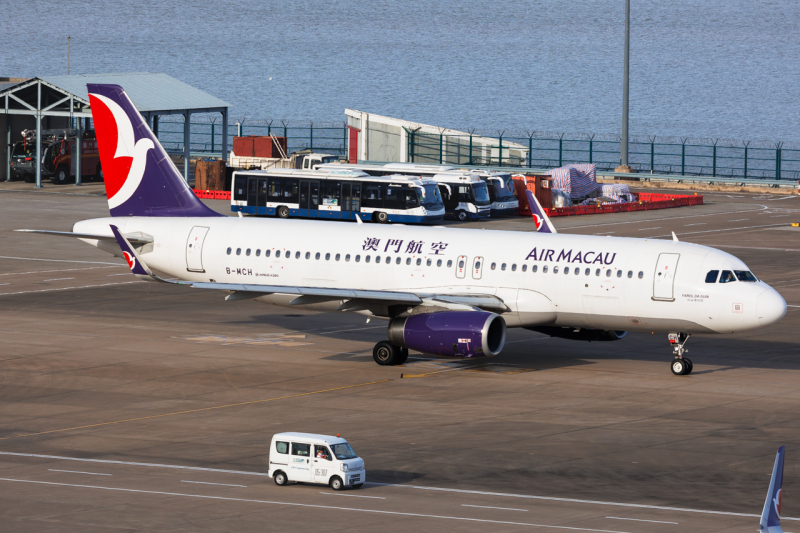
[408, 130, 800, 180]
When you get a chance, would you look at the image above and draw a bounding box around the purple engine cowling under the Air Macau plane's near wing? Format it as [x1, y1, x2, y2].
[389, 311, 506, 357]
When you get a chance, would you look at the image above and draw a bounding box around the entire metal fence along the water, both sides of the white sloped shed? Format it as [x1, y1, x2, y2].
[150, 118, 800, 180]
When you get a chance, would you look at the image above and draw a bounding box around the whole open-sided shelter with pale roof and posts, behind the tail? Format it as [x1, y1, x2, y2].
[0, 72, 230, 188]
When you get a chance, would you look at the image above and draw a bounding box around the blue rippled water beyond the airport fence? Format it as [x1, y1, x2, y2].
[0, 0, 800, 142]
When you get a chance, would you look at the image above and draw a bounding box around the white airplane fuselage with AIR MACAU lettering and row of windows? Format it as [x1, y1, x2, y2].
[74, 217, 786, 333]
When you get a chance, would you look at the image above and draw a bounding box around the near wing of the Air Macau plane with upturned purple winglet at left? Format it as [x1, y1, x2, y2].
[111, 225, 509, 316]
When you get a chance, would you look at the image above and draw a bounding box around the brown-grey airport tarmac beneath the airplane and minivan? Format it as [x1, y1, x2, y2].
[0, 192, 800, 533]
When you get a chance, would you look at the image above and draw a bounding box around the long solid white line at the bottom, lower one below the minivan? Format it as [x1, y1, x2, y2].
[0, 478, 632, 533]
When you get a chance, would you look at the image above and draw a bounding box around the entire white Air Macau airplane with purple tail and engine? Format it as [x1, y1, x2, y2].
[18, 84, 786, 375]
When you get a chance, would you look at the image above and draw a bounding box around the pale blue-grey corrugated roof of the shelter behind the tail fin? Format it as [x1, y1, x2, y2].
[40, 72, 230, 114]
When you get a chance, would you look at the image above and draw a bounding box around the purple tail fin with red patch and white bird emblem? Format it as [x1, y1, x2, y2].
[87, 83, 222, 217]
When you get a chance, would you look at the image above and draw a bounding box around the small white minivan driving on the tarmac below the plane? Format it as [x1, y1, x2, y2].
[269, 433, 366, 490]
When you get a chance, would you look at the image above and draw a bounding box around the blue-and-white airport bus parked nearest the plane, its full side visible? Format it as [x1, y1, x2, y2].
[231, 168, 445, 223]
